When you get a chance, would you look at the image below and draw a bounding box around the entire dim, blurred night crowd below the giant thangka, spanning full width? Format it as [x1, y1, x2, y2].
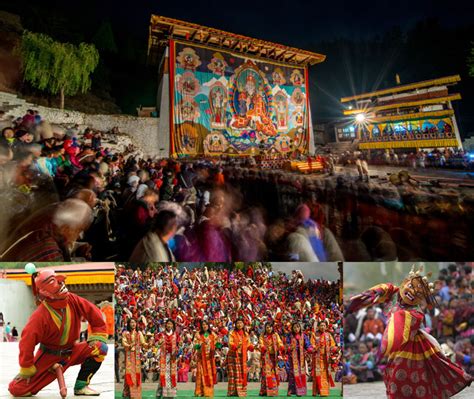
[0, 111, 474, 262]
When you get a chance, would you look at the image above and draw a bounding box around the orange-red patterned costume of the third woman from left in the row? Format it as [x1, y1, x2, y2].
[194, 331, 218, 398]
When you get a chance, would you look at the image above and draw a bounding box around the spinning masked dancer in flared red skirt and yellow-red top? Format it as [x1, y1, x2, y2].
[347, 267, 472, 399]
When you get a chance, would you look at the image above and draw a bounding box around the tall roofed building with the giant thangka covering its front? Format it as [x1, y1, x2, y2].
[148, 15, 325, 157]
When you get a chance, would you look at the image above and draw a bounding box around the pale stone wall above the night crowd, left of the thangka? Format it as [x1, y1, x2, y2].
[0, 92, 169, 157]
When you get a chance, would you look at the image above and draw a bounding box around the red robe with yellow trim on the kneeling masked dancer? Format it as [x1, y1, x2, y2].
[8, 293, 107, 396]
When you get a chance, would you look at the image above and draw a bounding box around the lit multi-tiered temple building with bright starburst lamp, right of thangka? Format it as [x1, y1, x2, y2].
[335, 75, 462, 150]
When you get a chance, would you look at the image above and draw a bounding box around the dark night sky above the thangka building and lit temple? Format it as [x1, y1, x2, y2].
[0, 0, 474, 135]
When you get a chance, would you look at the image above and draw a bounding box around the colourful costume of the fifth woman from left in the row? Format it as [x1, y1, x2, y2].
[259, 333, 284, 396]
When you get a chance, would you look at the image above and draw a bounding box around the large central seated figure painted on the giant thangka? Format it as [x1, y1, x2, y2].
[231, 68, 277, 136]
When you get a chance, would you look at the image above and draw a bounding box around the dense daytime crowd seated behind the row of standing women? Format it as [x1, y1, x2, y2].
[115, 265, 342, 382]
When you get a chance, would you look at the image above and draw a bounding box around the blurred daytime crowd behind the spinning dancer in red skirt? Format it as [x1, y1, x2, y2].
[343, 264, 474, 384]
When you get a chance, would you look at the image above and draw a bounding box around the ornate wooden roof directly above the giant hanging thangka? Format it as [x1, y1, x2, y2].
[148, 15, 326, 67]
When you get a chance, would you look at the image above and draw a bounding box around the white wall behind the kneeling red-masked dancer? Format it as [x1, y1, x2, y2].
[0, 279, 36, 334]
